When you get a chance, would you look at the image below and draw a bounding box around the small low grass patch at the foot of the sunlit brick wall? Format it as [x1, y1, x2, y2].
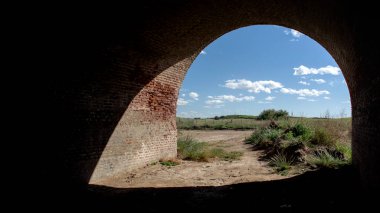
[177, 136, 243, 161]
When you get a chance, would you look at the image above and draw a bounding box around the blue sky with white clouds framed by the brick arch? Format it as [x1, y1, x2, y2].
[177, 25, 351, 117]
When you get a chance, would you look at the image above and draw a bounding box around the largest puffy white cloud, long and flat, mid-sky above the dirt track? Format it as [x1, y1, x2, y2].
[224, 79, 283, 93]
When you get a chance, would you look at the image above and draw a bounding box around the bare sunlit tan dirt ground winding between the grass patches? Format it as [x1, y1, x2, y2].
[96, 130, 294, 188]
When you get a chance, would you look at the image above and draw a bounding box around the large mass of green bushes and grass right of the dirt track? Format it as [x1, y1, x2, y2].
[246, 119, 351, 174]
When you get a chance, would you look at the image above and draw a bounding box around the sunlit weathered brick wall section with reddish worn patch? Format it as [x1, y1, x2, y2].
[90, 57, 193, 183]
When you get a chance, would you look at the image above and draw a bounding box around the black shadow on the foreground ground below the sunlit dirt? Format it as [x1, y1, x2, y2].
[50, 167, 373, 212]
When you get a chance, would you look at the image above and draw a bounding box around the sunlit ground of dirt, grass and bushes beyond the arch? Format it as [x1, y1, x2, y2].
[98, 115, 351, 188]
